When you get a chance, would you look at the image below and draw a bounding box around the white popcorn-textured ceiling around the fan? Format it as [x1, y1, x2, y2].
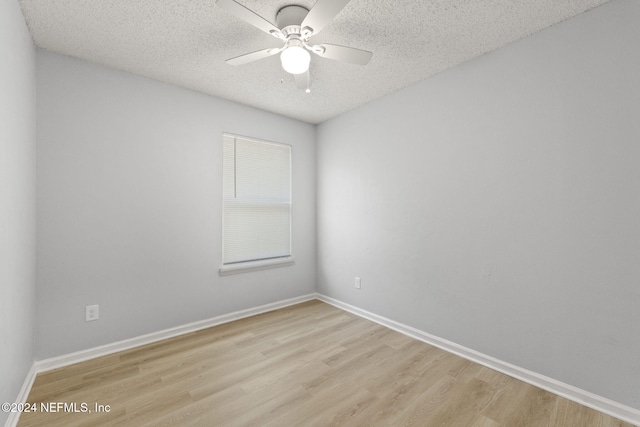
[20, 0, 609, 123]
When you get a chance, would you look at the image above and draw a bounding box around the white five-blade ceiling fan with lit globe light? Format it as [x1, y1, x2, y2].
[216, 0, 373, 93]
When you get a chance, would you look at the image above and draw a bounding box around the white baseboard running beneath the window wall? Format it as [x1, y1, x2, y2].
[35, 294, 316, 373]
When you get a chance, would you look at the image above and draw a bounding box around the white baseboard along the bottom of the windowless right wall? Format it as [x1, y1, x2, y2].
[317, 294, 640, 426]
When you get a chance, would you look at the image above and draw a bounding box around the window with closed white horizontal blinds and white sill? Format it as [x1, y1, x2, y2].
[220, 134, 293, 274]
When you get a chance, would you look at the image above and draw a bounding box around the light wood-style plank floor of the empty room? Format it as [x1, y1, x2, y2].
[18, 300, 631, 427]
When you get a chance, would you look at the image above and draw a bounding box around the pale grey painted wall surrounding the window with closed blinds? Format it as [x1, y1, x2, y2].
[36, 51, 316, 359]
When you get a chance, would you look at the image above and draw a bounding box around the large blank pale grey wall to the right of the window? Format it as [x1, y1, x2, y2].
[317, 0, 640, 408]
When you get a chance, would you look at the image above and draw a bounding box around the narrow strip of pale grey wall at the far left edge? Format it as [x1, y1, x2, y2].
[0, 0, 36, 424]
